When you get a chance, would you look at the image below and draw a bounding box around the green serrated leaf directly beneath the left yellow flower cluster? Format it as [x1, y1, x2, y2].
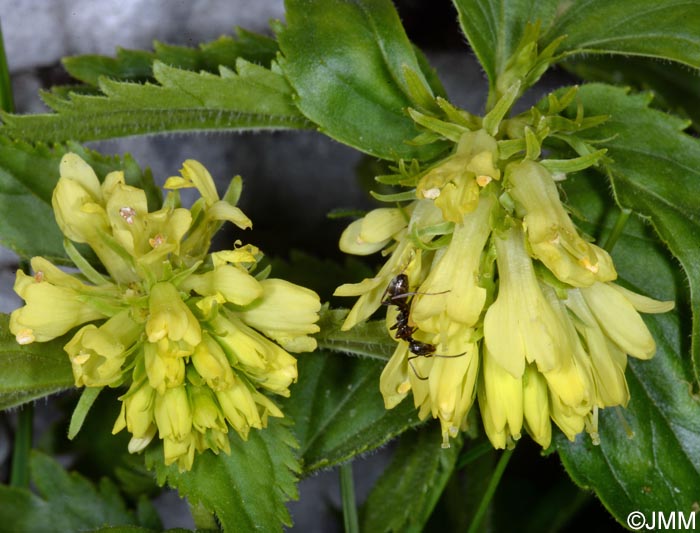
[146, 418, 300, 531]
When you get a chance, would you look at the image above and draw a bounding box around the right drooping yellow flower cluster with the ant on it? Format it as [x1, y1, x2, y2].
[336, 130, 673, 448]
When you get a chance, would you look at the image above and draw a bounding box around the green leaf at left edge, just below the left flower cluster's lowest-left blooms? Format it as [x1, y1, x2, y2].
[0, 314, 74, 409]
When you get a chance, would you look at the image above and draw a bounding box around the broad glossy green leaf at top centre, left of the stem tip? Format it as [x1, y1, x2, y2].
[278, 0, 447, 160]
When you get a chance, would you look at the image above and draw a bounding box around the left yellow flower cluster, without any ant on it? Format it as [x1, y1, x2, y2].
[10, 153, 320, 470]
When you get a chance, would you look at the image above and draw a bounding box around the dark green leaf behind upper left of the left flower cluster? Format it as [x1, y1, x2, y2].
[0, 136, 160, 263]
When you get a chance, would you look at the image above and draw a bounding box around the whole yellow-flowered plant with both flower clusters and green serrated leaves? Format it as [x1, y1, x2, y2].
[0, 0, 700, 532]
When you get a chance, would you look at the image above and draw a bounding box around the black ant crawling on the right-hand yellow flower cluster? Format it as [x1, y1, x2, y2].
[382, 273, 467, 380]
